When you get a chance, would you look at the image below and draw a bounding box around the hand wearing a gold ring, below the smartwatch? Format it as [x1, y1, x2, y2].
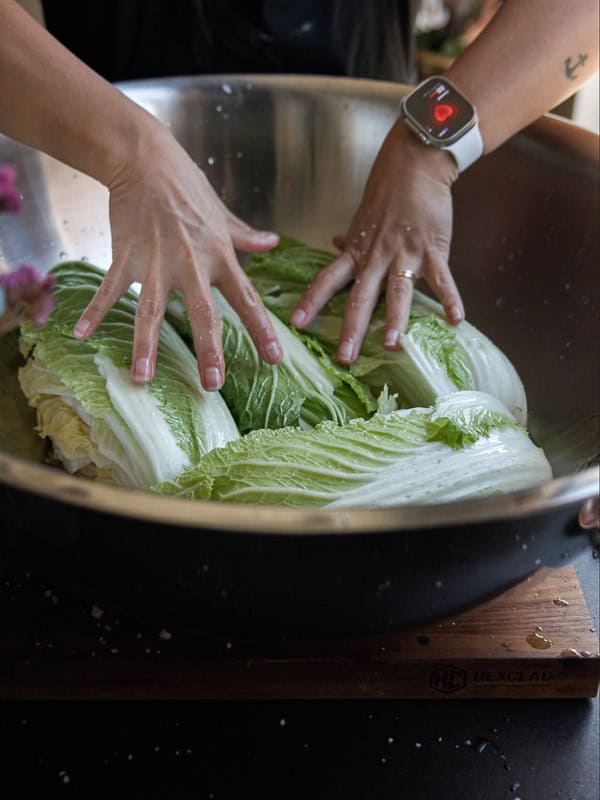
[291, 120, 464, 364]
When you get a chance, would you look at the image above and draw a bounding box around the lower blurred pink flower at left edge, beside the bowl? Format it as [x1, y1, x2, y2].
[0, 264, 54, 334]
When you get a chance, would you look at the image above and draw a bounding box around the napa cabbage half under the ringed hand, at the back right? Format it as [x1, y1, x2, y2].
[247, 237, 527, 425]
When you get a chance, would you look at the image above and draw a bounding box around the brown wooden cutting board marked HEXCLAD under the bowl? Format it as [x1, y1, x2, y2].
[0, 566, 600, 700]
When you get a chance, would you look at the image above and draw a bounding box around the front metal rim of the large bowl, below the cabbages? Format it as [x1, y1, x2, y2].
[0, 453, 600, 536]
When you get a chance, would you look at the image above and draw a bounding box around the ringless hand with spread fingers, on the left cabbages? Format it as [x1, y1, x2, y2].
[74, 122, 283, 391]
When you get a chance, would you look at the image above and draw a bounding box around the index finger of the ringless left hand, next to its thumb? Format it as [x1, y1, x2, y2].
[219, 268, 283, 364]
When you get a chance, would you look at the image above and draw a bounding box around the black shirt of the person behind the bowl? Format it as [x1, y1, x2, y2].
[42, 0, 418, 83]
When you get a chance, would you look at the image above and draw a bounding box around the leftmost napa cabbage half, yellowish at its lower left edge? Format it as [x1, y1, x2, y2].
[19, 262, 239, 488]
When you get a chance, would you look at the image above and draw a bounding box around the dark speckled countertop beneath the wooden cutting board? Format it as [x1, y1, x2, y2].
[0, 548, 600, 800]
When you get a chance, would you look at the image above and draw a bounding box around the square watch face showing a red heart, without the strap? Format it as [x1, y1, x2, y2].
[404, 77, 476, 145]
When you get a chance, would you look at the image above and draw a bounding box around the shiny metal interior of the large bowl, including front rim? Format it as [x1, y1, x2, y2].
[0, 76, 600, 533]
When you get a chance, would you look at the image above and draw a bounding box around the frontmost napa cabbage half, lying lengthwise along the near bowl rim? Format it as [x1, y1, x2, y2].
[153, 391, 551, 508]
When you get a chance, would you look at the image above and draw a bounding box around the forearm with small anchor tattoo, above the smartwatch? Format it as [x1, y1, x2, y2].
[447, 0, 598, 153]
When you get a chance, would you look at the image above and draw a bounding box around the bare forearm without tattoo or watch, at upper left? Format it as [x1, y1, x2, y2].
[0, 0, 163, 185]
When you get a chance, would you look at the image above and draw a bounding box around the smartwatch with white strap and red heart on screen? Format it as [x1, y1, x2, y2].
[402, 75, 483, 172]
